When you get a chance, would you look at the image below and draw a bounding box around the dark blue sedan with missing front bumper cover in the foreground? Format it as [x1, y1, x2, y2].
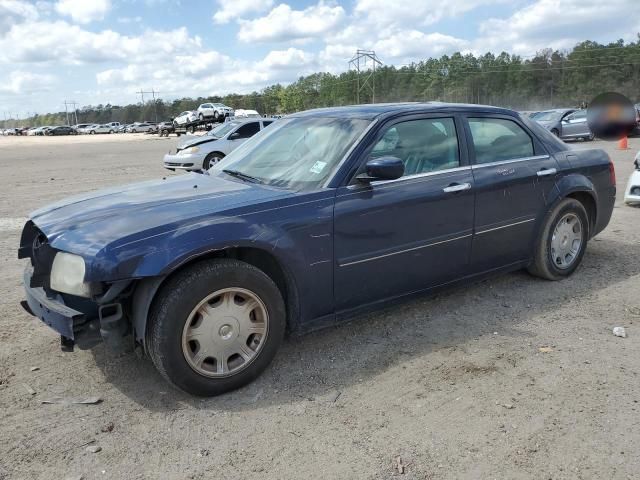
[19, 103, 615, 395]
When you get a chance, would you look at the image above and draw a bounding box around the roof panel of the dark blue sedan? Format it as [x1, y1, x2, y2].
[290, 102, 518, 120]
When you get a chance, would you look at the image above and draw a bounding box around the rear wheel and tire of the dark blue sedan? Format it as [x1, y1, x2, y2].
[528, 198, 590, 280]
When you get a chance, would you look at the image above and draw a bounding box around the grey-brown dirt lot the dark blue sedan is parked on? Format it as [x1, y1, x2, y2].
[0, 135, 640, 480]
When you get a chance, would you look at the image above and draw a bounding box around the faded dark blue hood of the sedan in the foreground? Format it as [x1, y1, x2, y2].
[30, 173, 291, 258]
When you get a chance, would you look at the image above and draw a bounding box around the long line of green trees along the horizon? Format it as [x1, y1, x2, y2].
[0, 37, 640, 127]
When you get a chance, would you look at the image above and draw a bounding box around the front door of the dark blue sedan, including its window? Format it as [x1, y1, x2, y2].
[334, 116, 474, 312]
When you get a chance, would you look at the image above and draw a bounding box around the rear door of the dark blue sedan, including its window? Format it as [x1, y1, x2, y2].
[465, 114, 557, 273]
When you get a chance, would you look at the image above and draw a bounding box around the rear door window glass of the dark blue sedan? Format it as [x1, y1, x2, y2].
[469, 118, 533, 164]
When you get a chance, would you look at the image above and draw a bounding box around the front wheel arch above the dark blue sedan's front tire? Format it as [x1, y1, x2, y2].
[130, 246, 300, 351]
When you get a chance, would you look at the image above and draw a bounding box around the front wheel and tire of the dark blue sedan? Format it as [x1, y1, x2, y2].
[146, 259, 286, 396]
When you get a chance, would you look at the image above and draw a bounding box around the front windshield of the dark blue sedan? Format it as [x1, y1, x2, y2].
[212, 117, 370, 190]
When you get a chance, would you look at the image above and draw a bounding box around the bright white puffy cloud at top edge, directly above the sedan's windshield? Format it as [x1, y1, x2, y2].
[238, 1, 346, 43]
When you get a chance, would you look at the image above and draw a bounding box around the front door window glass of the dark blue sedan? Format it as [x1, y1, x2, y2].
[371, 118, 460, 176]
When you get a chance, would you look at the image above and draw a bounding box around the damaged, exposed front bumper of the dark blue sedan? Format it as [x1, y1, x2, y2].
[21, 266, 131, 351]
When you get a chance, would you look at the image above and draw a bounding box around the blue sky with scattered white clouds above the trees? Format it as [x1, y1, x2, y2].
[0, 0, 640, 118]
